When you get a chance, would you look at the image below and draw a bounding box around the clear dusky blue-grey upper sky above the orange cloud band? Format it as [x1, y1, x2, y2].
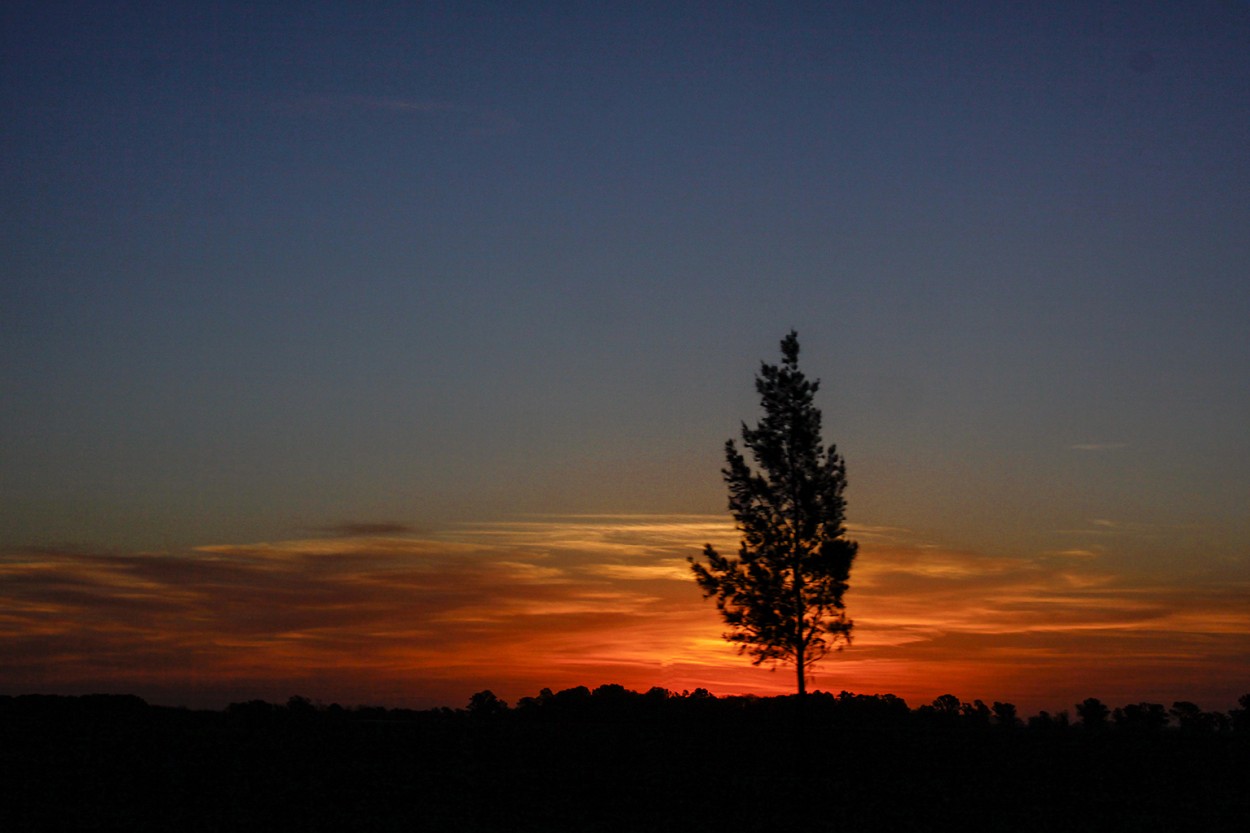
[0, 1, 1250, 705]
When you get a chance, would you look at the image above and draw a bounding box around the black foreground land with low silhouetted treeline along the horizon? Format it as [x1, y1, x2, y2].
[0, 687, 1250, 833]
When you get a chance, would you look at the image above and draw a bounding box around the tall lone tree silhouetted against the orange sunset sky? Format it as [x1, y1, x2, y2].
[689, 330, 858, 695]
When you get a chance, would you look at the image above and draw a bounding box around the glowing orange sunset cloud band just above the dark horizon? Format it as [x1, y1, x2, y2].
[0, 515, 1250, 713]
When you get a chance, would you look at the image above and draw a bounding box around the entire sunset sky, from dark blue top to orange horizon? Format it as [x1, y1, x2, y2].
[0, 0, 1250, 709]
